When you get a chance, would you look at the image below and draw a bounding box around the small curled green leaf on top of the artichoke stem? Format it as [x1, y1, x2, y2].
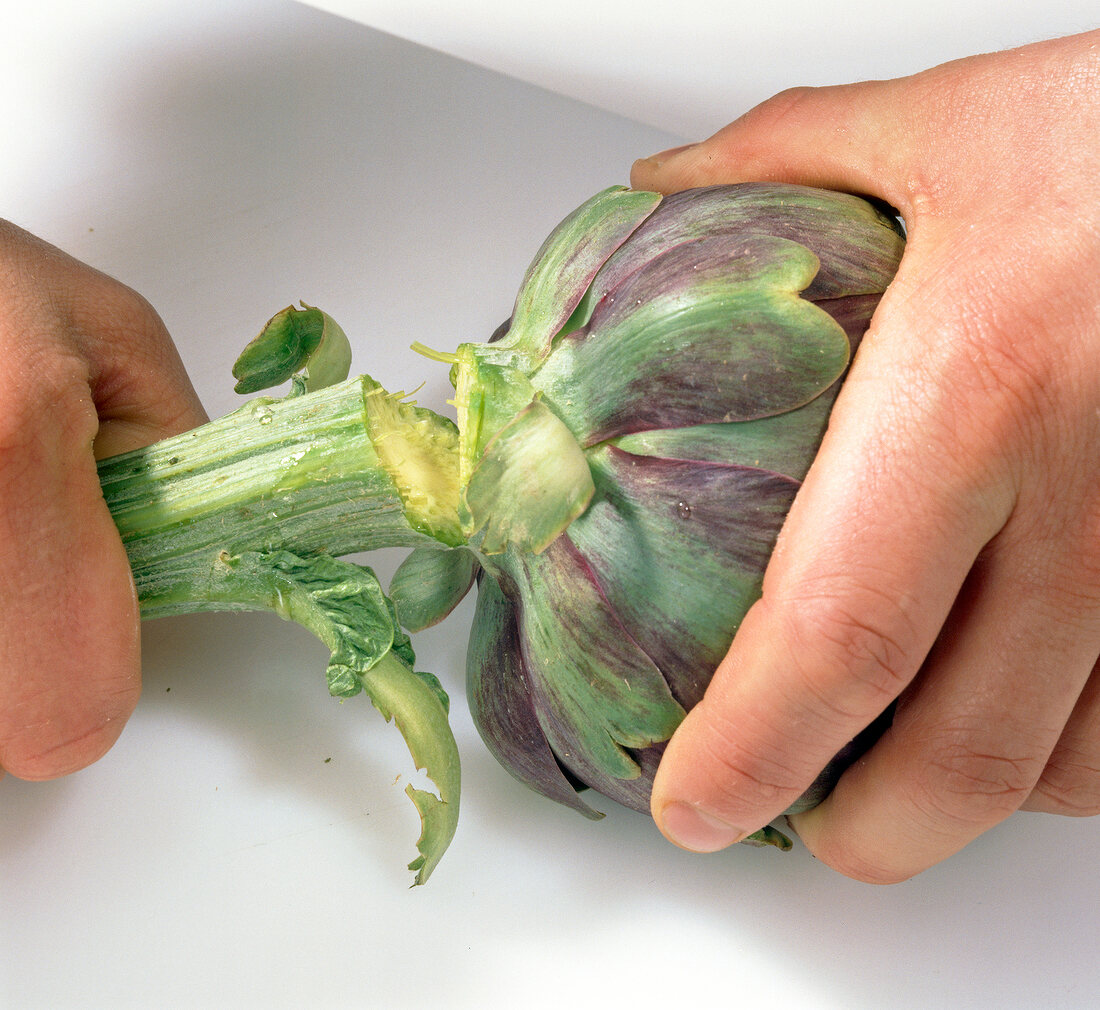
[233, 303, 351, 394]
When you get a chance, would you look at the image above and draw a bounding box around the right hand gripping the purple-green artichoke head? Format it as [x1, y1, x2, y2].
[631, 32, 1100, 882]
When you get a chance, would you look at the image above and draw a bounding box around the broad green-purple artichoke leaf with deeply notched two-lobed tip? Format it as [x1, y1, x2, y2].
[531, 235, 849, 447]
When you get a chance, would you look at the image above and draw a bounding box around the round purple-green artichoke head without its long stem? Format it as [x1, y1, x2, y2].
[391, 184, 903, 839]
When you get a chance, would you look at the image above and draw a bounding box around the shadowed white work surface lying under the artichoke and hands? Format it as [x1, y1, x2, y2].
[0, 0, 1100, 1010]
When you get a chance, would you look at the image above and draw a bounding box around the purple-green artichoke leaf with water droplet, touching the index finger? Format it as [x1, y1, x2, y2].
[569, 447, 799, 709]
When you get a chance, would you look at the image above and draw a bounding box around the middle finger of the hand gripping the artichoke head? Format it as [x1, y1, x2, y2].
[792, 495, 1100, 882]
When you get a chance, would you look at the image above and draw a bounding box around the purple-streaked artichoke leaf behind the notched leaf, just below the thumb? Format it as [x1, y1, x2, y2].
[593, 183, 904, 300]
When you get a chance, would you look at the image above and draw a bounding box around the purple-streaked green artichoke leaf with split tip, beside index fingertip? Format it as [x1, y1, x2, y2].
[494, 536, 684, 792]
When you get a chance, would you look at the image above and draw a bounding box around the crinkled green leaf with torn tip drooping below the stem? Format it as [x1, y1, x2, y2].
[209, 551, 461, 883]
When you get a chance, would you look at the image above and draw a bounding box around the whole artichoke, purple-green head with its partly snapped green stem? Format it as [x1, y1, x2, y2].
[100, 184, 903, 882]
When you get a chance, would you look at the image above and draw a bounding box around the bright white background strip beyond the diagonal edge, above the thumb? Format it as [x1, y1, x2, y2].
[305, 0, 1100, 138]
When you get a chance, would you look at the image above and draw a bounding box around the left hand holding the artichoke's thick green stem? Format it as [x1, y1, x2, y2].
[0, 221, 206, 779]
